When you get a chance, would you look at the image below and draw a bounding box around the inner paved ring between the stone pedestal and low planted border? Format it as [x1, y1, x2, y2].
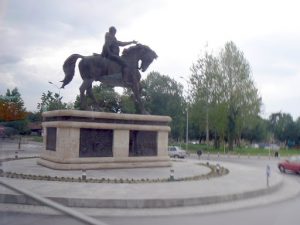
[2, 158, 211, 180]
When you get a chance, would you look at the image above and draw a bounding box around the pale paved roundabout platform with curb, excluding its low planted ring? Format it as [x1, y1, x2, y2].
[0, 159, 282, 209]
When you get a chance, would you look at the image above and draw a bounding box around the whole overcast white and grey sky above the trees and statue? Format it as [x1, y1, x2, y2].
[0, 0, 300, 119]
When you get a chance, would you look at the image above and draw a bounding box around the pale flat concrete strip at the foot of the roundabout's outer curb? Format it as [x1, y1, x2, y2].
[0, 178, 300, 218]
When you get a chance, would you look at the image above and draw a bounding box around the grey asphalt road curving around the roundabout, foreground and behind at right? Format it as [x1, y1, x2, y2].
[0, 157, 300, 225]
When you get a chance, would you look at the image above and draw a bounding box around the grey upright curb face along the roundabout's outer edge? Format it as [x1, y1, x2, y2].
[0, 176, 283, 209]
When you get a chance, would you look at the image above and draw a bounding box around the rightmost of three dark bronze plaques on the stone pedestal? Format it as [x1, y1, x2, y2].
[129, 131, 157, 156]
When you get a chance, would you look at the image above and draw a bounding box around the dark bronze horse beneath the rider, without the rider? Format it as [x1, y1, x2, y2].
[61, 44, 157, 114]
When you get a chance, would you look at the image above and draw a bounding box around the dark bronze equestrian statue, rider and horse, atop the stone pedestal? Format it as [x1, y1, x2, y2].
[61, 27, 158, 114]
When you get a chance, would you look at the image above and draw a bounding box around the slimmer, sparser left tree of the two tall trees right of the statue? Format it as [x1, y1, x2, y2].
[190, 51, 226, 147]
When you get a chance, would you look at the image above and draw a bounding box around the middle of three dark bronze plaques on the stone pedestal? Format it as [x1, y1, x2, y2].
[79, 128, 113, 157]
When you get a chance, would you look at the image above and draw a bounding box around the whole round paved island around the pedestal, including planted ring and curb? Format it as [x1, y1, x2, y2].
[0, 153, 290, 215]
